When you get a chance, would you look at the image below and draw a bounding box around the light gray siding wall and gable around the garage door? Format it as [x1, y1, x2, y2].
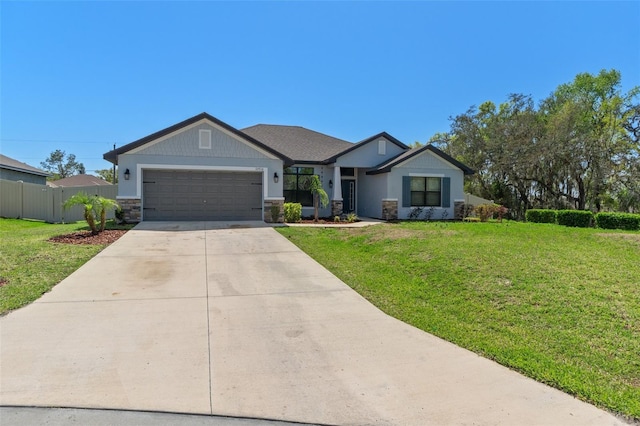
[118, 123, 283, 198]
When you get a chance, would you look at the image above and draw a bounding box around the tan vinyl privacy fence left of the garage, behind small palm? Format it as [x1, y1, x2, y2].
[0, 179, 118, 223]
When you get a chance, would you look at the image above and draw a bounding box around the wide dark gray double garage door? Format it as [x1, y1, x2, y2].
[142, 170, 262, 220]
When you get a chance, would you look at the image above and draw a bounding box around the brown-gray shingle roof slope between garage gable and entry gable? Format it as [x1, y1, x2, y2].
[242, 124, 355, 163]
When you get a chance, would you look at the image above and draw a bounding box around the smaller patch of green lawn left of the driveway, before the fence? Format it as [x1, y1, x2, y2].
[0, 219, 131, 315]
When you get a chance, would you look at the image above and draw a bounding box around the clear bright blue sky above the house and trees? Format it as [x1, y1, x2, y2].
[0, 0, 640, 175]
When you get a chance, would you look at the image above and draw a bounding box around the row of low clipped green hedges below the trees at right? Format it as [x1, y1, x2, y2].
[525, 209, 640, 231]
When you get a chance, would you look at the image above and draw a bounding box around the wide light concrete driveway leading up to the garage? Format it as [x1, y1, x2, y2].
[0, 222, 623, 425]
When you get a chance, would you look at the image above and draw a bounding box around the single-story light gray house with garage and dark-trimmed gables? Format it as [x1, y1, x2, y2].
[104, 113, 473, 222]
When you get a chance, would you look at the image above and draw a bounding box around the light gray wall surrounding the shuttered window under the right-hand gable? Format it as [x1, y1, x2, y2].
[388, 151, 464, 219]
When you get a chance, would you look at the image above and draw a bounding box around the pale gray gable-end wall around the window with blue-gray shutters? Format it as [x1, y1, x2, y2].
[389, 151, 464, 219]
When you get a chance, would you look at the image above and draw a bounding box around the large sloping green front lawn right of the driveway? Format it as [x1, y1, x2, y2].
[278, 222, 640, 420]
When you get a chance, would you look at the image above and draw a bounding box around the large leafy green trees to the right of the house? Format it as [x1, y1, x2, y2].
[431, 70, 640, 218]
